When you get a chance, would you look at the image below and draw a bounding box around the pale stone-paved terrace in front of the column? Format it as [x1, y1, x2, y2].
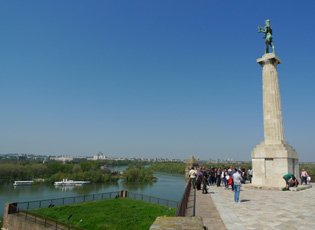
[209, 184, 315, 230]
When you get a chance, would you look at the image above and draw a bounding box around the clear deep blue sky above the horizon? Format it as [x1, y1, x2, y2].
[0, 0, 315, 161]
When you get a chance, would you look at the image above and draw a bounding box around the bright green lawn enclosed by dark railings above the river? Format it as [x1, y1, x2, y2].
[32, 198, 176, 230]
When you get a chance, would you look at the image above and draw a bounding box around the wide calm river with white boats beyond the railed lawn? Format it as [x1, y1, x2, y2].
[0, 173, 185, 217]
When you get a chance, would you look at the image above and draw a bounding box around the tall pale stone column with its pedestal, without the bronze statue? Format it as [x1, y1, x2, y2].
[252, 53, 299, 188]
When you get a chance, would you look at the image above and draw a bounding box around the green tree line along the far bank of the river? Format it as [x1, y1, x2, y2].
[0, 159, 315, 183]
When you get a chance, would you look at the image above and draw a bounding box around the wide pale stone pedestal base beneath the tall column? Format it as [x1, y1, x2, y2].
[252, 142, 299, 188]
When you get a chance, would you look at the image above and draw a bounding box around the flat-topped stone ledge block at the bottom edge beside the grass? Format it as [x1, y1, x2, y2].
[150, 216, 204, 230]
